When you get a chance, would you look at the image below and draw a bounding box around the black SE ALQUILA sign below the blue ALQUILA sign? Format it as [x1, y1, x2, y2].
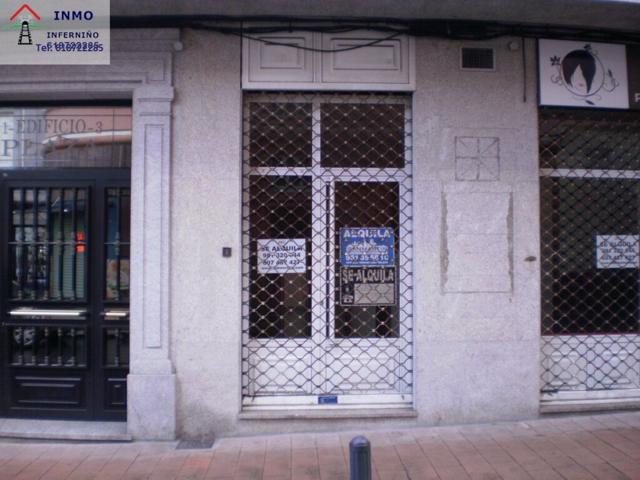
[340, 267, 396, 307]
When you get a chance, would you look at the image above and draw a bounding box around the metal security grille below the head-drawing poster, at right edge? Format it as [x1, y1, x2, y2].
[539, 109, 640, 394]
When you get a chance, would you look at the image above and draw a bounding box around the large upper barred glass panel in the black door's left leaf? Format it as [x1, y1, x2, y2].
[9, 188, 87, 301]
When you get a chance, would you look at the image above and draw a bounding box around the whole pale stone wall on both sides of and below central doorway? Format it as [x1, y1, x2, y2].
[171, 31, 540, 437]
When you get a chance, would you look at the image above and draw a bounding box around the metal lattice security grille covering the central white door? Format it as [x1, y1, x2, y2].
[242, 93, 413, 403]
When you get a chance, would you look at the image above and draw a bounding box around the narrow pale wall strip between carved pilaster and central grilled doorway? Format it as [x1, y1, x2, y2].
[171, 31, 242, 436]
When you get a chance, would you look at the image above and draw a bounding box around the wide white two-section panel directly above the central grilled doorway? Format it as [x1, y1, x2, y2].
[242, 30, 415, 91]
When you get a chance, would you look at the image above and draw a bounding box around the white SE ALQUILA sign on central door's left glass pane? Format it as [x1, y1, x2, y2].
[257, 238, 307, 274]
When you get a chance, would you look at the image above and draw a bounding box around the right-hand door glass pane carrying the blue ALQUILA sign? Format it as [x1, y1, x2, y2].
[335, 182, 399, 338]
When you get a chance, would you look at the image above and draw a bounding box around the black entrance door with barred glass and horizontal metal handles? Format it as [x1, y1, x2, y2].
[0, 169, 131, 419]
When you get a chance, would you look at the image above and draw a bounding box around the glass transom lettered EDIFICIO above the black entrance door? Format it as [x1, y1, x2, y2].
[0, 106, 131, 168]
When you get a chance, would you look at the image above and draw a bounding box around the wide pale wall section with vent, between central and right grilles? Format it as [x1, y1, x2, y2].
[413, 39, 540, 423]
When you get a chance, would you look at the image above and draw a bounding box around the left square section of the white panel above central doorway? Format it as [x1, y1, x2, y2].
[244, 32, 313, 82]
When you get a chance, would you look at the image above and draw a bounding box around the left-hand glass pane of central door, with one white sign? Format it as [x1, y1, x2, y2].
[249, 176, 311, 338]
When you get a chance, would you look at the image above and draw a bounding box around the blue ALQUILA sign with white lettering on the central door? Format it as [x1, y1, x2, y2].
[340, 227, 394, 267]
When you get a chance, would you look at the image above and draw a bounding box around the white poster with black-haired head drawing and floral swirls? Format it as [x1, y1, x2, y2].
[538, 40, 629, 108]
